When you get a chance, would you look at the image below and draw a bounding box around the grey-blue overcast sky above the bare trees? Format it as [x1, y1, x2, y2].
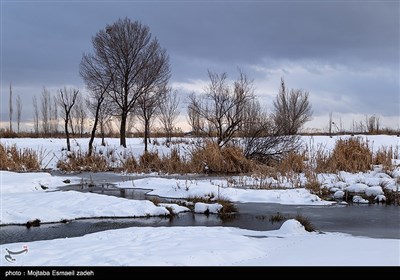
[1, 0, 400, 131]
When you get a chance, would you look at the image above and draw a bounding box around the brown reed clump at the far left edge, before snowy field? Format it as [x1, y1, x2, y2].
[0, 144, 40, 171]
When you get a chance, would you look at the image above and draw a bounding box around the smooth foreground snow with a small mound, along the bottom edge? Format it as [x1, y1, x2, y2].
[1, 220, 400, 266]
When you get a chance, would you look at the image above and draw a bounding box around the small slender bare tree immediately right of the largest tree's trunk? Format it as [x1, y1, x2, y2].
[136, 87, 166, 152]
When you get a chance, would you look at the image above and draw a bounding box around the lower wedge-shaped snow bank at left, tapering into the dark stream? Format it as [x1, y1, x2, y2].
[0, 191, 169, 225]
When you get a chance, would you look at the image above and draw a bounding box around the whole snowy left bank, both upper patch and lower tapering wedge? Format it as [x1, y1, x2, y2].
[0, 171, 169, 225]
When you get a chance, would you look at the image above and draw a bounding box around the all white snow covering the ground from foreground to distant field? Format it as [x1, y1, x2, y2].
[0, 135, 400, 266]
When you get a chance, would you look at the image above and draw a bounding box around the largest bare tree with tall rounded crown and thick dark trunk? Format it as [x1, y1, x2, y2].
[81, 18, 170, 147]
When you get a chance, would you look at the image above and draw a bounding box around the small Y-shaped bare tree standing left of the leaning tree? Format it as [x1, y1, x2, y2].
[57, 87, 79, 151]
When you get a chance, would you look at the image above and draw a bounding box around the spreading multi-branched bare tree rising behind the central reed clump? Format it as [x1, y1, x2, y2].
[189, 71, 253, 148]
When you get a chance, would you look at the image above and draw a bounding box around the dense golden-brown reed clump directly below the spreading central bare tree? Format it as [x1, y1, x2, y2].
[190, 141, 253, 174]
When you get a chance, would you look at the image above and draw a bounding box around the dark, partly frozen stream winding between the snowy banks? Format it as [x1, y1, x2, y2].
[0, 173, 400, 244]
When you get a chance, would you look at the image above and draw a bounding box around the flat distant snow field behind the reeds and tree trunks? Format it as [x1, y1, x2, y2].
[0, 135, 400, 169]
